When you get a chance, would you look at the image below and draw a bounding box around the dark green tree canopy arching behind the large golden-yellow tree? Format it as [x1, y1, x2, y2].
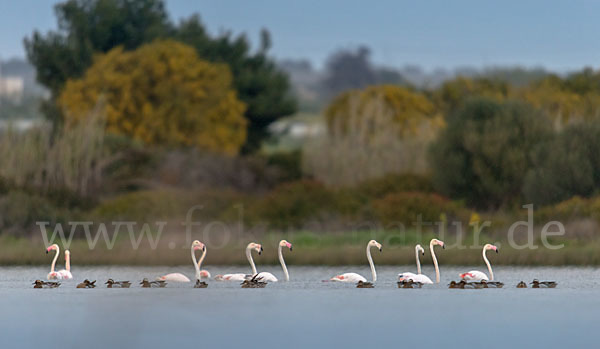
[25, 0, 296, 151]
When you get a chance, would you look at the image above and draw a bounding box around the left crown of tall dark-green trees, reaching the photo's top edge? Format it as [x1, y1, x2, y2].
[25, 0, 171, 96]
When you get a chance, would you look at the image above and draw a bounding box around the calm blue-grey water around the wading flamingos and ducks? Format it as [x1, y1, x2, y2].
[0, 266, 600, 348]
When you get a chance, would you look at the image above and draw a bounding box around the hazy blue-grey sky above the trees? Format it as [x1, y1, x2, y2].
[0, 0, 600, 71]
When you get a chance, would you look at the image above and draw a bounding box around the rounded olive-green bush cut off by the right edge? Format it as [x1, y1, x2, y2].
[523, 121, 600, 205]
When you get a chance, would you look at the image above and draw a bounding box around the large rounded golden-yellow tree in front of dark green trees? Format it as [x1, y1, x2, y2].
[58, 40, 246, 154]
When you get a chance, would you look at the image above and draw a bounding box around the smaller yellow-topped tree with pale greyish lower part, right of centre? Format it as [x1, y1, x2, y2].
[302, 85, 442, 186]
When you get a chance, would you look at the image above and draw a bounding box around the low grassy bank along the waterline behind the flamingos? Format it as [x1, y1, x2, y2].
[0, 232, 600, 266]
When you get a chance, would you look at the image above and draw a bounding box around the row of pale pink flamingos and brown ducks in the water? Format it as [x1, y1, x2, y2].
[33, 239, 557, 289]
